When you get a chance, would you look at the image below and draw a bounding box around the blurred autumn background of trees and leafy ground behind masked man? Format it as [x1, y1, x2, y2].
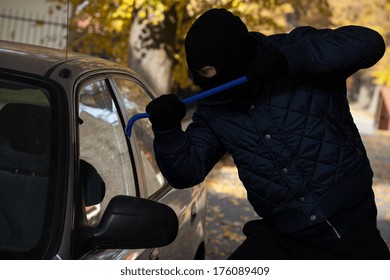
[0, 0, 390, 259]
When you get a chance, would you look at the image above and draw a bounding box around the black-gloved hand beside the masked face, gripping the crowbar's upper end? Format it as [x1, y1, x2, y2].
[246, 51, 288, 83]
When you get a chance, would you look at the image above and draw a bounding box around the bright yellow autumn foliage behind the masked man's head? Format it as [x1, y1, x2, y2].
[47, 0, 390, 88]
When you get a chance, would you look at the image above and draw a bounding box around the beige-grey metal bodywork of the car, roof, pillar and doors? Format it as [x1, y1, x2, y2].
[0, 41, 206, 259]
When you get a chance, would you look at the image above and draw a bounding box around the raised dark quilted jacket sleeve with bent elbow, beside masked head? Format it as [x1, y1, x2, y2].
[281, 25, 386, 77]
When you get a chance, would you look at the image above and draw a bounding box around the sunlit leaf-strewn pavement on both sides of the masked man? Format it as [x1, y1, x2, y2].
[206, 106, 390, 260]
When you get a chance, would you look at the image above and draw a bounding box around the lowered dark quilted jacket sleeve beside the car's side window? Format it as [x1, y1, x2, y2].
[154, 109, 226, 189]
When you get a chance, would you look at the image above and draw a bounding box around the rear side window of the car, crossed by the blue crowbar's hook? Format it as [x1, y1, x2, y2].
[113, 77, 165, 196]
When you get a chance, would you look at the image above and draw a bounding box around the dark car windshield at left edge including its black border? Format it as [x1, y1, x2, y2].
[0, 74, 62, 259]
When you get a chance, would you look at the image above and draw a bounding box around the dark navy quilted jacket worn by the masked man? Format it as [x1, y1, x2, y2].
[154, 26, 385, 240]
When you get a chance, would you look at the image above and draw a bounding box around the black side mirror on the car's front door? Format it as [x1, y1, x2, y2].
[90, 195, 179, 249]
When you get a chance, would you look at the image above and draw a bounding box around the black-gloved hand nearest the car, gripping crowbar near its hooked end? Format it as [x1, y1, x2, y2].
[146, 93, 186, 131]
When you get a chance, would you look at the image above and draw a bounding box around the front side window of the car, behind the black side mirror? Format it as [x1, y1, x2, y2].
[79, 77, 136, 225]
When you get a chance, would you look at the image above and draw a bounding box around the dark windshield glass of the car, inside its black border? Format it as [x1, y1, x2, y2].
[0, 78, 55, 258]
